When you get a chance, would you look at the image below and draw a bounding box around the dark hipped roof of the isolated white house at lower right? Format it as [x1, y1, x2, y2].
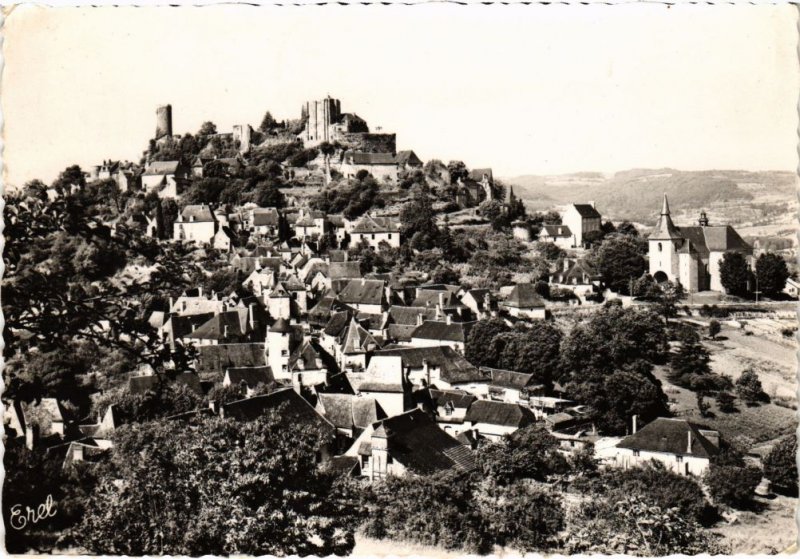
[617, 417, 719, 458]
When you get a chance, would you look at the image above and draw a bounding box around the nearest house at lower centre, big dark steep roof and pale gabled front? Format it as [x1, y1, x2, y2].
[345, 409, 476, 481]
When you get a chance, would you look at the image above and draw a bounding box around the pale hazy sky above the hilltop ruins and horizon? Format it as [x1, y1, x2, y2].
[2, 4, 800, 184]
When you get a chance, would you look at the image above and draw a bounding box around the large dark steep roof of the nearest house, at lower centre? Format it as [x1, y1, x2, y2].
[374, 409, 476, 475]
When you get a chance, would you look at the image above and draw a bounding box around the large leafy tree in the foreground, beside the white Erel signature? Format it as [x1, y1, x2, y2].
[75, 409, 354, 556]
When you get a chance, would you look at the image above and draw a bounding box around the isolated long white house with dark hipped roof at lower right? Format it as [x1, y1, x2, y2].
[613, 416, 719, 476]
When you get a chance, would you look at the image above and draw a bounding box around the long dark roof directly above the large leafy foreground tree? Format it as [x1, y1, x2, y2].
[222, 388, 335, 434]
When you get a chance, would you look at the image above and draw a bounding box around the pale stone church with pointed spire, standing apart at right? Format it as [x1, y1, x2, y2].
[648, 194, 753, 293]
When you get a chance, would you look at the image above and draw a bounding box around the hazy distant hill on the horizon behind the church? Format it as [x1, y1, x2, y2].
[503, 169, 796, 225]
